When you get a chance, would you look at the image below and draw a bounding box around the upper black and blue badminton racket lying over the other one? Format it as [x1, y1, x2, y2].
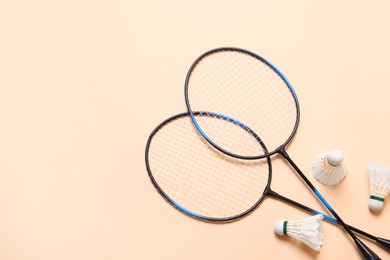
[185, 48, 380, 259]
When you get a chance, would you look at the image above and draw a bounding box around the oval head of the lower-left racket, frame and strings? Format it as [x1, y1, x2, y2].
[145, 112, 272, 222]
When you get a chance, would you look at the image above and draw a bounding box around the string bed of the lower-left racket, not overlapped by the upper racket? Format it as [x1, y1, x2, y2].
[149, 117, 267, 218]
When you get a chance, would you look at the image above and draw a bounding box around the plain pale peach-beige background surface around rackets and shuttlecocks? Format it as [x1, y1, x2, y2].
[0, 0, 390, 260]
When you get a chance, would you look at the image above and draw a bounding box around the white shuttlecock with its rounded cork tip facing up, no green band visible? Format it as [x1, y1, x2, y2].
[312, 150, 347, 186]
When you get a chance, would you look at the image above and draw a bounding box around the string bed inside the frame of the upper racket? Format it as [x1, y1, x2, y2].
[188, 51, 296, 155]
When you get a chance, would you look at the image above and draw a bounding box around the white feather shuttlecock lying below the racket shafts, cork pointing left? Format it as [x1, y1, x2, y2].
[274, 215, 324, 251]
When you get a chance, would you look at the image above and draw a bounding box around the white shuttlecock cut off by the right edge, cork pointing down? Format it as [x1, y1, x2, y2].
[368, 163, 390, 211]
